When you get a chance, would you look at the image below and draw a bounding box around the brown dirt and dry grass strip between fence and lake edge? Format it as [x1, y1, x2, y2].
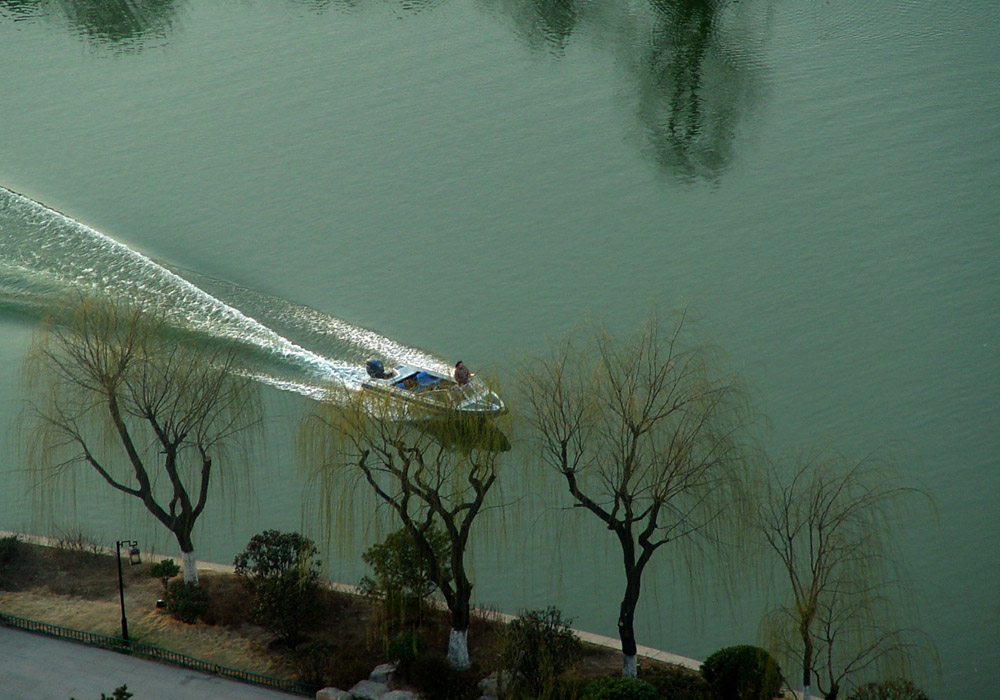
[0, 542, 621, 688]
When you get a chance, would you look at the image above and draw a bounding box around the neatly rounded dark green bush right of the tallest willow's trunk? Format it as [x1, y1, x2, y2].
[701, 644, 782, 700]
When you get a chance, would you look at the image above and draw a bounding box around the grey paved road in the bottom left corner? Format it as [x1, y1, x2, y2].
[0, 626, 302, 700]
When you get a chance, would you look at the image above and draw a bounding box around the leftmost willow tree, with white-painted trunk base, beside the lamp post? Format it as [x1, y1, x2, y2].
[22, 295, 260, 583]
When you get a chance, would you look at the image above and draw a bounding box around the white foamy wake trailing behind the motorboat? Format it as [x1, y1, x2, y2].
[0, 187, 444, 399]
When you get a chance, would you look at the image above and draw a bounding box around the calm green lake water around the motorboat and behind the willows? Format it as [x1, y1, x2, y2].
[0, 0, 1000, 698]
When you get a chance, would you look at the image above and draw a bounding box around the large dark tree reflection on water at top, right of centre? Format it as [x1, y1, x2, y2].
[490, 0, 754, 182]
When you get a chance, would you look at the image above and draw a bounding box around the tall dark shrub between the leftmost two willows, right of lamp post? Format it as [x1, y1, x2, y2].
[234, 530, 319, 646]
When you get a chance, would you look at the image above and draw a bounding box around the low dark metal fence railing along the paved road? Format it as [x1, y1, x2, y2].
[0, 613, 319, 696]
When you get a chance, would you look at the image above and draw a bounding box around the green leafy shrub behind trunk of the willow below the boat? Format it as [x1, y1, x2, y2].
[359, 528, 451, 617]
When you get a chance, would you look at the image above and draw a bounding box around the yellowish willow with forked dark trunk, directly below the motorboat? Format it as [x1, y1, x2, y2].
[300, 390, 509, 668]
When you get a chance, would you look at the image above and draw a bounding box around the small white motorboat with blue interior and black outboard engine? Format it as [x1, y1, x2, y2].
[361, 360, 507, 416]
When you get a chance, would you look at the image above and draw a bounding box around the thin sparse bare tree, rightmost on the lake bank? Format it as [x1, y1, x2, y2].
[758, 450, 931, 700]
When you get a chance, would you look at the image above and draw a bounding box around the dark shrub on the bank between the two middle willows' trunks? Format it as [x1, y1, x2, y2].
[500, 606, 581, 696]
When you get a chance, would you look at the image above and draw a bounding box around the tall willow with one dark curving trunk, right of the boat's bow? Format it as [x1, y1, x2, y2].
[524, 314, 750, 677]
